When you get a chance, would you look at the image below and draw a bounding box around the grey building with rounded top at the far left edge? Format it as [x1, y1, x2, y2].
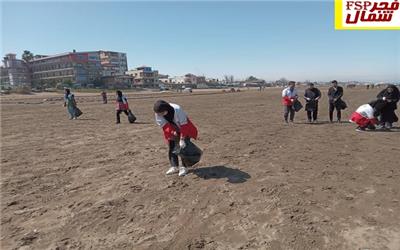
[0, 54, 31, 88]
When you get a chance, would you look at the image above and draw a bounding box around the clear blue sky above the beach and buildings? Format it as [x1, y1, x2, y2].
[1, 1, 400, 81]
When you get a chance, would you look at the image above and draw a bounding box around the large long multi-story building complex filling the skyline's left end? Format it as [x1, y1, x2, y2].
[1, 50, 127, 88]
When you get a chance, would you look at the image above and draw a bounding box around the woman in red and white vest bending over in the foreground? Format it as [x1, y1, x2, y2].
[153, 100, 197, 176]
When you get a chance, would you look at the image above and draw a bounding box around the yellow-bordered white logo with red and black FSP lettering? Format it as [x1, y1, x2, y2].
[335, 0, 400, 30]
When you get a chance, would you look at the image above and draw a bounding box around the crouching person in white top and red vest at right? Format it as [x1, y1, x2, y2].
[350, 100, 386, 131]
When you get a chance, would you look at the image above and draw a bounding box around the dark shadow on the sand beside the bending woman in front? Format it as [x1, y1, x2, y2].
[192, 166, 251, 183]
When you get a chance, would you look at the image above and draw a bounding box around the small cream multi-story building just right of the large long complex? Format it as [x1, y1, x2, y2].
[127, 66, 159, 88]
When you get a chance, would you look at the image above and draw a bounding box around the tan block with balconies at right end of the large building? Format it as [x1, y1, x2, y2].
[99, 50, 128, 76]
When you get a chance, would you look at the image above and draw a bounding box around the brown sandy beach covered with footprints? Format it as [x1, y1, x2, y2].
[1, 88, 400, 250]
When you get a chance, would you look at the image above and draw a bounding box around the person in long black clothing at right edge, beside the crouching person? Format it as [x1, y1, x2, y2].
[377, 84, 400, 129]
